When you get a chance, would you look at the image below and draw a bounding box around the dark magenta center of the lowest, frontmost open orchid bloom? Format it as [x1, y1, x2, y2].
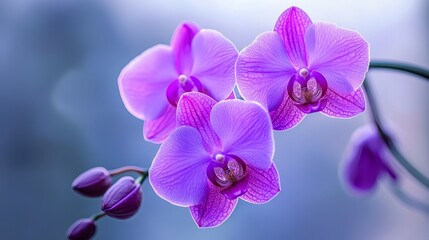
[207, 153, 247, 199]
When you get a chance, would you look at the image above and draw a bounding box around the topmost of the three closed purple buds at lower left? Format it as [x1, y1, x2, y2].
[72, 167, 112, 197]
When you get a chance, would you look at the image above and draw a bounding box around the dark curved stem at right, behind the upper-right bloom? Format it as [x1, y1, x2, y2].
[363, 61, 429, 189]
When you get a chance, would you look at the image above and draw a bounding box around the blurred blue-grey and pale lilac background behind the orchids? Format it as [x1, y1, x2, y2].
[0, 0, 429, 240]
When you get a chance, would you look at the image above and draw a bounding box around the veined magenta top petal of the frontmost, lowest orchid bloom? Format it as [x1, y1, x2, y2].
[177, 92, 220, 153]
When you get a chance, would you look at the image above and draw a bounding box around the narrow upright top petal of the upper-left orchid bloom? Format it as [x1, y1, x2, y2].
[170, 22, 200, 74]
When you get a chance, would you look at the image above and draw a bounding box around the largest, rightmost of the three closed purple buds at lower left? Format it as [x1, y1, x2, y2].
[101, 176, 142, 219]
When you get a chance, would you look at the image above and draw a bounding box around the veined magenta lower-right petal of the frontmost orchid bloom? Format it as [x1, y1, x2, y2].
[241, 163, 280, 204]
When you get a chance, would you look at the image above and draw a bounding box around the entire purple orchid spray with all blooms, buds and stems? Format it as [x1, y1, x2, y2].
[68, 4, 429, 239]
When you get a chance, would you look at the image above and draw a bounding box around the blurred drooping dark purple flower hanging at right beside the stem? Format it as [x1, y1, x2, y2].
[340, 126, 398, 194]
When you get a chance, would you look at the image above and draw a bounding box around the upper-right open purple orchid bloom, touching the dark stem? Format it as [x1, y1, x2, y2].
[236, 7, 369, 130]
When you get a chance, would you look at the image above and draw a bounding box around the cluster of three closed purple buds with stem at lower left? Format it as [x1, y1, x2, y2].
[67, 167, 147, 240]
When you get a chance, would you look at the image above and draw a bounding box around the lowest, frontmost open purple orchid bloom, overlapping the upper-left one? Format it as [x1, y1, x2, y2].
[149, 93, 280, 227]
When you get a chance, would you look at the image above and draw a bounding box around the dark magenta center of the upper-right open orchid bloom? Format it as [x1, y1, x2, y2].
[287, 68, 328, 113]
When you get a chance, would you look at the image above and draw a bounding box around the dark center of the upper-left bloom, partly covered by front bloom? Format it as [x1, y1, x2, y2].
[167, 74, 203, 107]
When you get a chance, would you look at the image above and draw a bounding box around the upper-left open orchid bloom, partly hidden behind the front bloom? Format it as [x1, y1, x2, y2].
[118, 22, 238, 143]
